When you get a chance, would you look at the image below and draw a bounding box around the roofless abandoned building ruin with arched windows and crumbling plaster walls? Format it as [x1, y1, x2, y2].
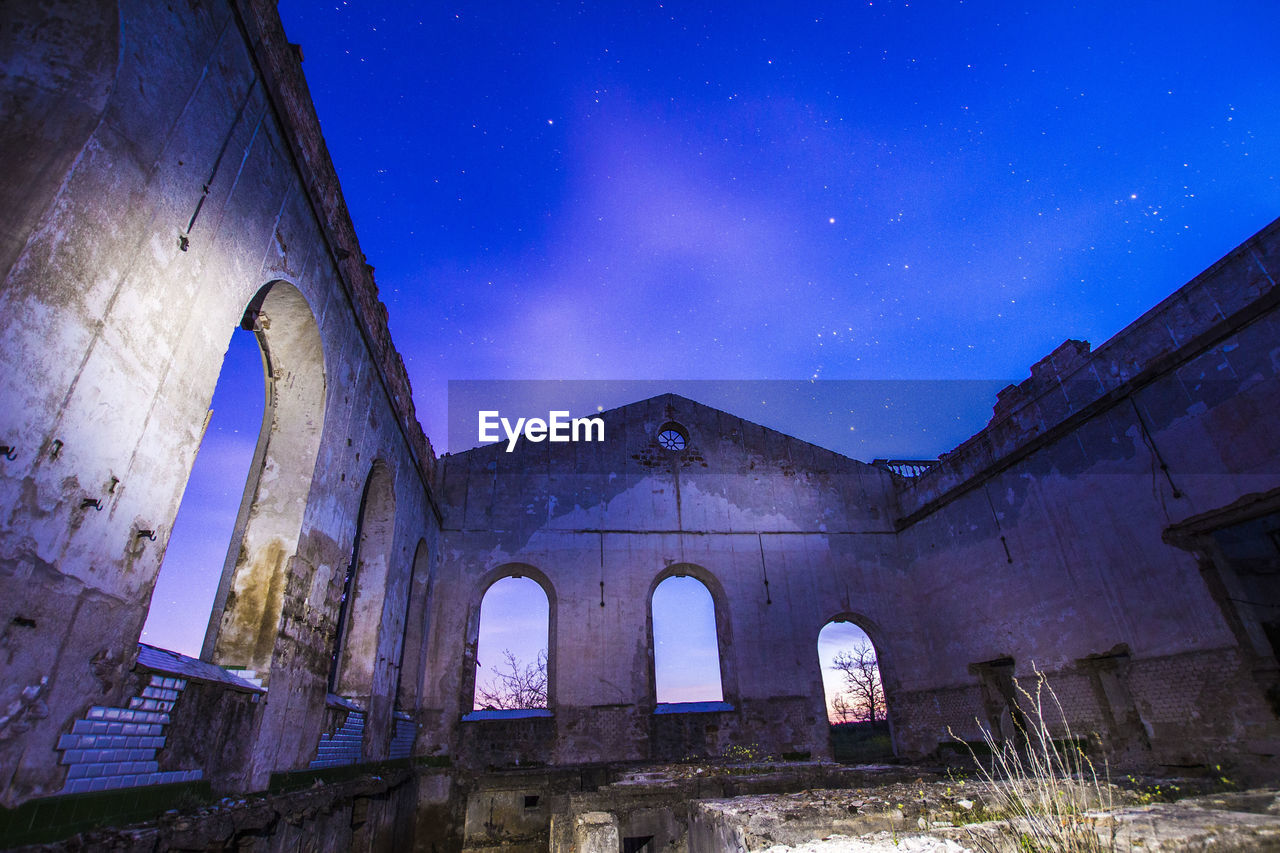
[0, 0, 1280, 850]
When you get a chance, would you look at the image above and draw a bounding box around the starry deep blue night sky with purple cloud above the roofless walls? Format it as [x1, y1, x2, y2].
[148, 0, 1280, 671]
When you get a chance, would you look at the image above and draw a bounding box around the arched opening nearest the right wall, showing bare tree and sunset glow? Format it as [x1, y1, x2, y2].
[818, 619, 893, 763]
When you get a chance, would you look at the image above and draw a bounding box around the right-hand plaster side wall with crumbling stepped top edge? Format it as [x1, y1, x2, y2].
[899, 216, 1280, 763]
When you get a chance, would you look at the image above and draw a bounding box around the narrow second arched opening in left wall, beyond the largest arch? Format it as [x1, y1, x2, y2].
[329, 460, 396, 699]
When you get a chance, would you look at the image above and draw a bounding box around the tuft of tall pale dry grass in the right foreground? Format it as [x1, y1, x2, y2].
[951, 671, 1116, 853]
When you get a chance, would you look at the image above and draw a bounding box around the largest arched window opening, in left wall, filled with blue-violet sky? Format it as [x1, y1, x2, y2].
[140, 329, 265, 657]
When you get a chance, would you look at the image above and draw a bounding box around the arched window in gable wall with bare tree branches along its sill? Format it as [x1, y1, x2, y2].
[472, 576, 550, 711]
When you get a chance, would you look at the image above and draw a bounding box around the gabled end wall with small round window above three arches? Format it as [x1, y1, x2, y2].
[424, 394, 919, 763]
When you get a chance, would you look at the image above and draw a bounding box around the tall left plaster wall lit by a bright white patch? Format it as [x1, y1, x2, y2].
[0, 0, 436, 803]
